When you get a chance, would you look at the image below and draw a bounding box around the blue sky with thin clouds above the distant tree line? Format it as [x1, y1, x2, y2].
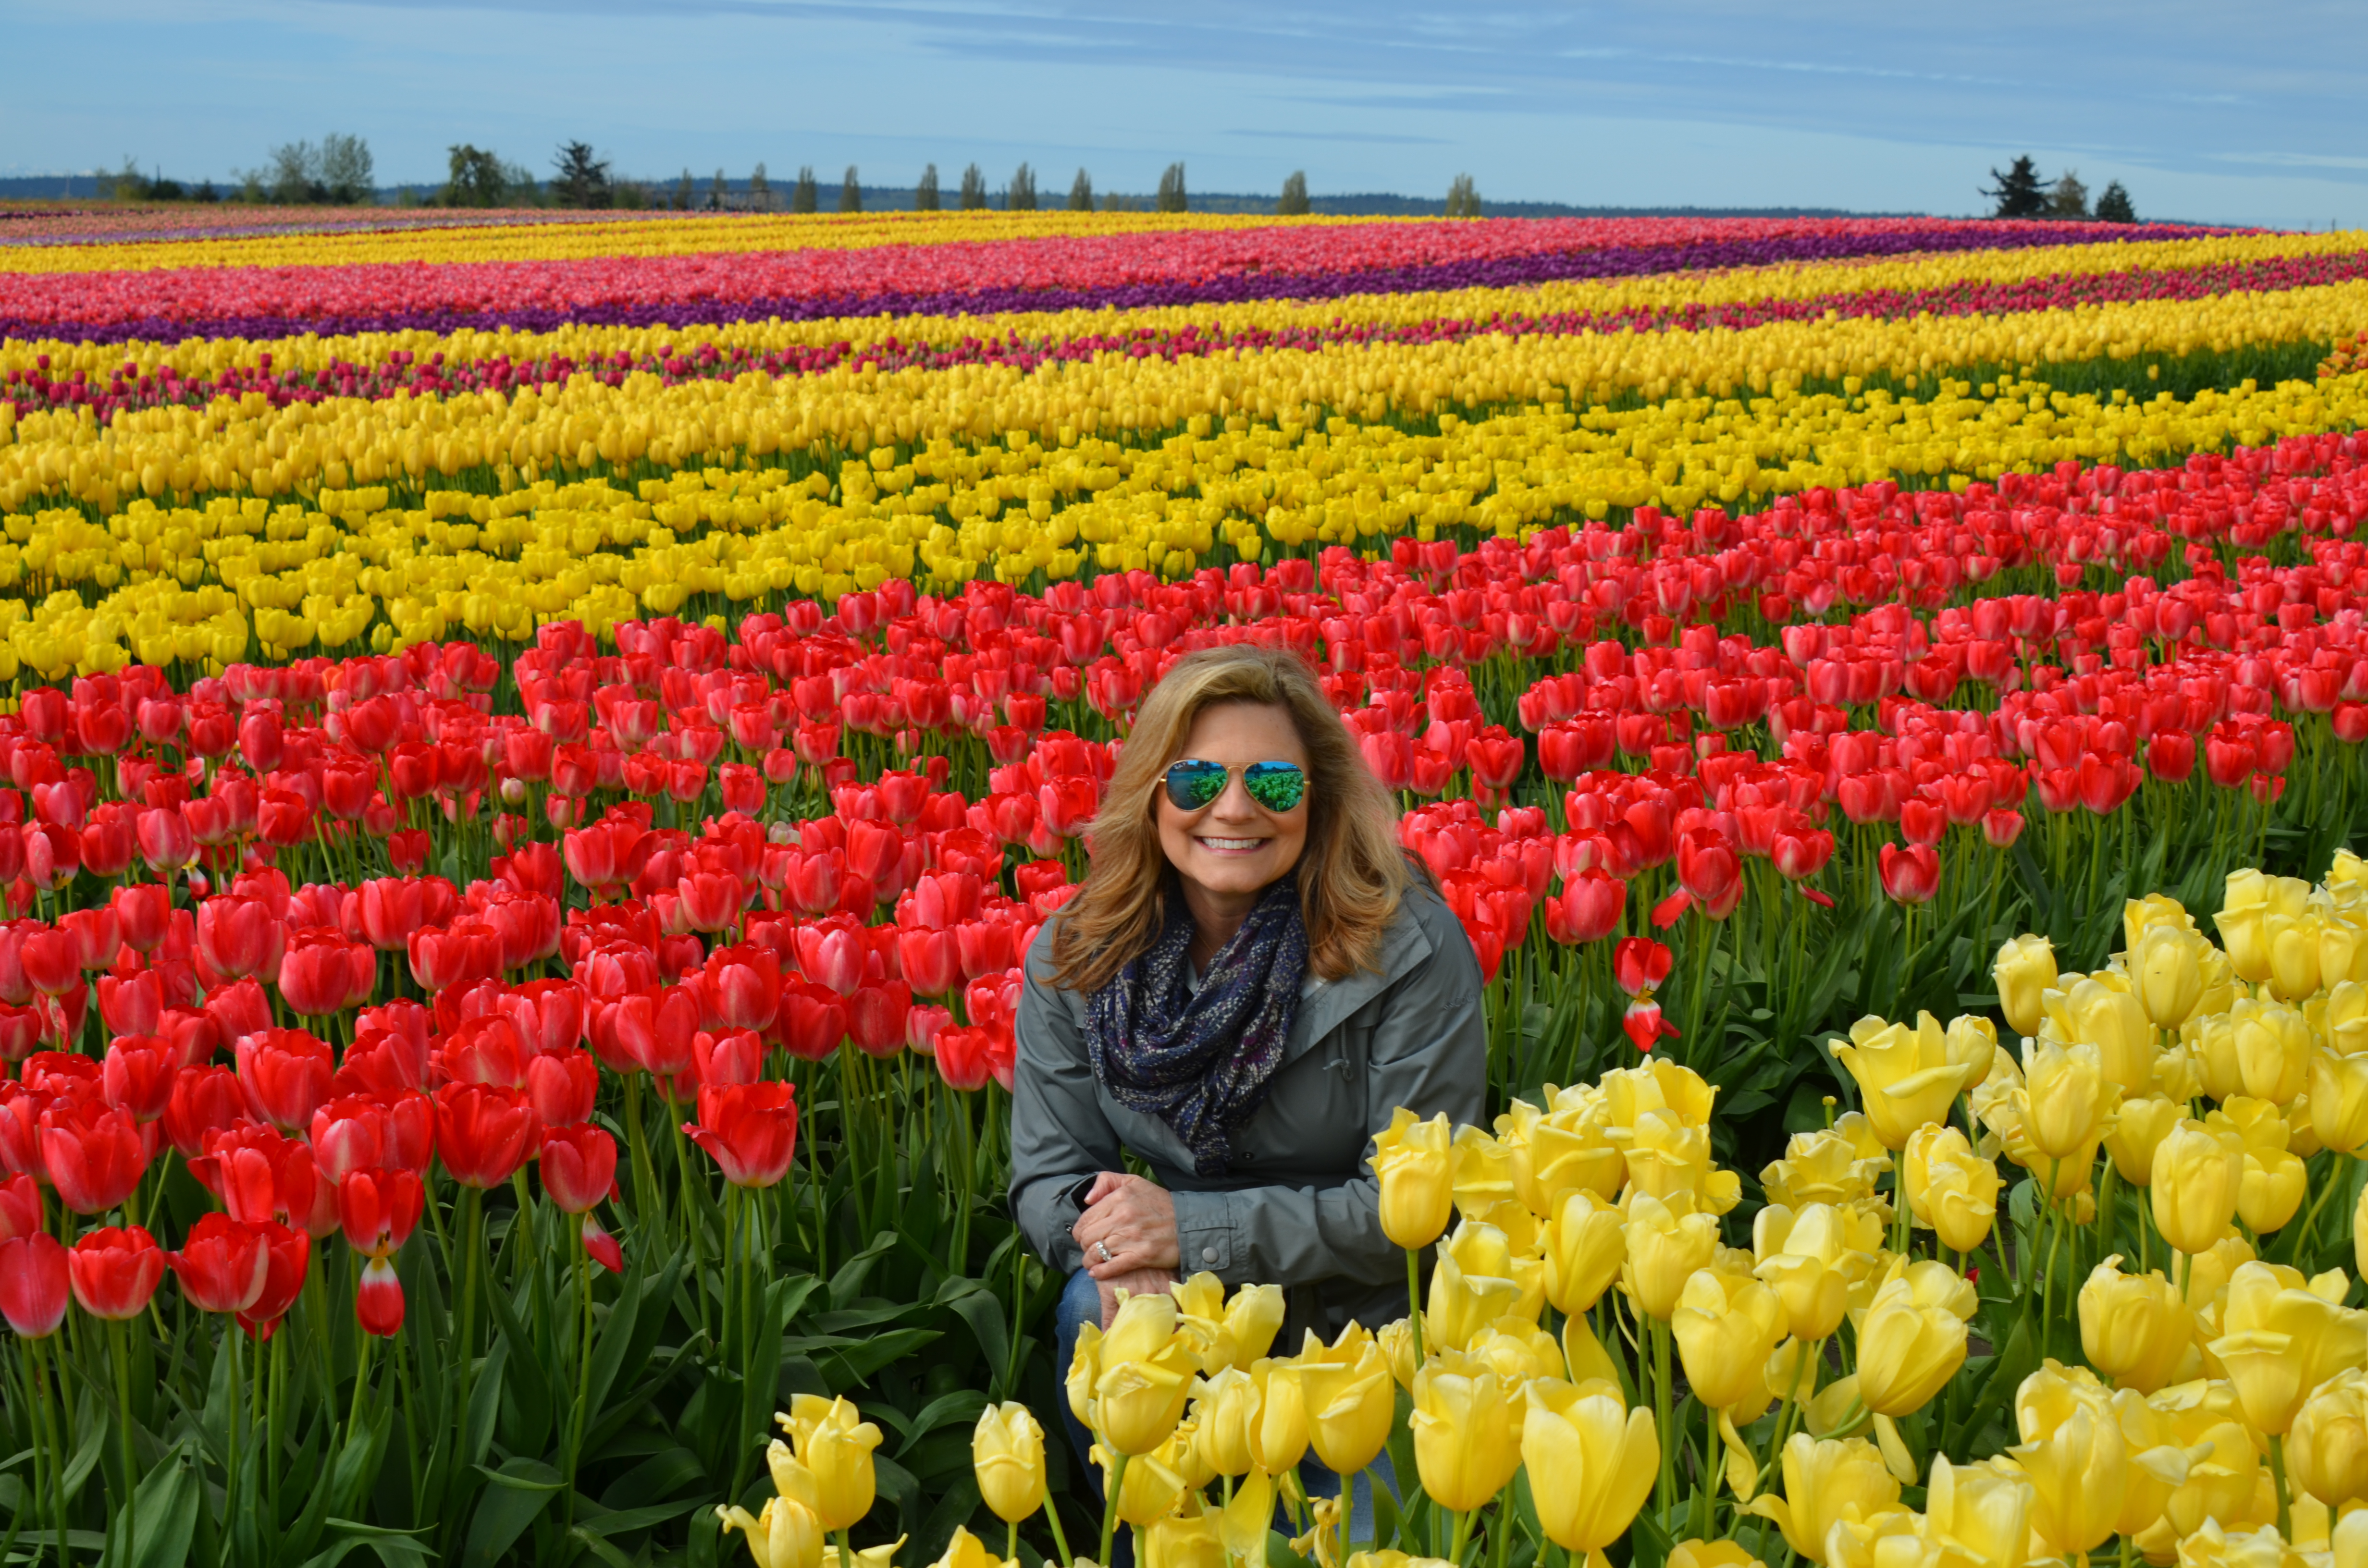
[0, 0, 2368, 230]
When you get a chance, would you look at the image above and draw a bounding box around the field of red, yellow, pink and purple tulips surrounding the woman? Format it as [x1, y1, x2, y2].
[0, 208, 2368, 1568]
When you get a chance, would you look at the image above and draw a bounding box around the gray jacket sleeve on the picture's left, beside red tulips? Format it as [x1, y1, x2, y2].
[1011, 921, 1125, 1274]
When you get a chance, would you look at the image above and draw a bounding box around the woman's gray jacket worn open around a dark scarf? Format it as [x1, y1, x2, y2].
[1011, 883, 1487, 1355]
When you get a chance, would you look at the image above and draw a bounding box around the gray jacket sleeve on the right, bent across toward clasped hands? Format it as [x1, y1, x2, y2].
[1174, 891, 1487, 1286]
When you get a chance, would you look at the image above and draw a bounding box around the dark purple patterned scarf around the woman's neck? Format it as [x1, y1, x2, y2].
[1085, 876, 1307, 1177]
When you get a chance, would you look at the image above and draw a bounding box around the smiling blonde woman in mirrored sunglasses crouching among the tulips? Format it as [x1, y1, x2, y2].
[1011, 647, 1487, 1497]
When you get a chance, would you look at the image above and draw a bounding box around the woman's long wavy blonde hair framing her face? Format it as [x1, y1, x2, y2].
[1051, 644, 1414, 992]
